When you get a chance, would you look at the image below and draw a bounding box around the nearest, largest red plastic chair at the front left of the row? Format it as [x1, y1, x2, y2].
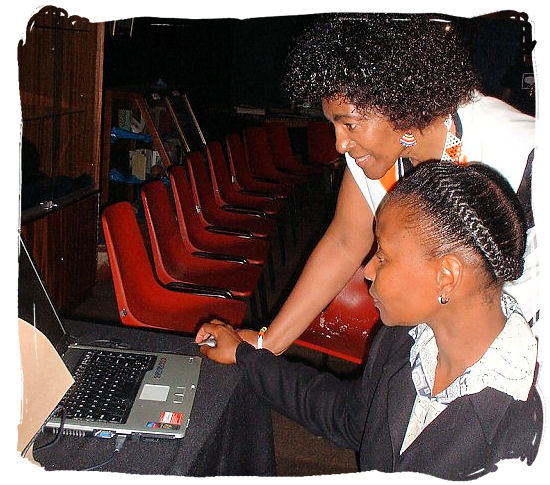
[101, 202, 246, 333]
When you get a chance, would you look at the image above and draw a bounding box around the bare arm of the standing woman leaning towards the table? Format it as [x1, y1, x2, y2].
[240, 169, 374, 354]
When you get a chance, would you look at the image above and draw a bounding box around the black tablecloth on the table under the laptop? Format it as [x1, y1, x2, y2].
[34, 321, 275, 476]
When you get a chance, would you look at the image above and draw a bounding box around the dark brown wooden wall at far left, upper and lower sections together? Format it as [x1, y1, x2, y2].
[18, 7, 104, 310]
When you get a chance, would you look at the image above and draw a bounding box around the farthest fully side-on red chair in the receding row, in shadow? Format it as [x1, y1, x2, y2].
[265, 121, 323, 179]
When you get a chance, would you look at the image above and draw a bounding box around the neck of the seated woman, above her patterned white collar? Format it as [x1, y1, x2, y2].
[430, 295, 506, 396]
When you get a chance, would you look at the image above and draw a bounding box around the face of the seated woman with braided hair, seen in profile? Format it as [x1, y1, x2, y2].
[364, 203, 440, 326]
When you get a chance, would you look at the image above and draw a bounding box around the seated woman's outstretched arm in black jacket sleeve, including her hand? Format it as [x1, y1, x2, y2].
[199, 320, 367, 450]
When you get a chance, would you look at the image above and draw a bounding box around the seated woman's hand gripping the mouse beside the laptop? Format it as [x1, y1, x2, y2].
[195, 320, 243, 364]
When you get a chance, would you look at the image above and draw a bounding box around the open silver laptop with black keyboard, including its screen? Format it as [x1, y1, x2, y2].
[18, 236, 201, 439]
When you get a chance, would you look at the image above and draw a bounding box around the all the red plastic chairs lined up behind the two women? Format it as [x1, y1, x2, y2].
[102, 119, 384, 363]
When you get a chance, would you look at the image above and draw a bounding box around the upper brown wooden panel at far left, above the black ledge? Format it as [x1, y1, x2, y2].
[18, 7, 103, 194]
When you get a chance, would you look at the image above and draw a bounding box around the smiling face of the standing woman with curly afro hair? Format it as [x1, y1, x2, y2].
[323, 97, 405, 179]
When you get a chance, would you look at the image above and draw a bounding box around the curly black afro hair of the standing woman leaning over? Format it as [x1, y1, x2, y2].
[284, 14, 478, 129]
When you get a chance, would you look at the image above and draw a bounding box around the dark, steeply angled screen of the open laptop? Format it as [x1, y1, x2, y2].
[17, 235, 66, 354]
